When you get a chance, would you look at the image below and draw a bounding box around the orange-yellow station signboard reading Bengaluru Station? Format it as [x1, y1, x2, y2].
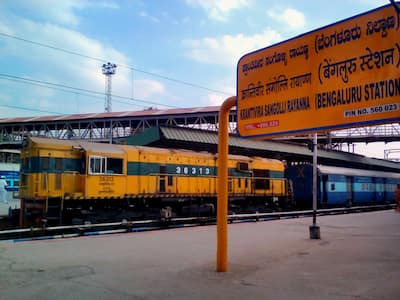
[237, 5, 400, 138]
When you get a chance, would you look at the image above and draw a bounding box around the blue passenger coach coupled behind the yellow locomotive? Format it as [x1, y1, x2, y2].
[286, 164, 400, 208]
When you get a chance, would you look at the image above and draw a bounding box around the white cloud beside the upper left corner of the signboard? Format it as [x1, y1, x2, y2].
[183, 29, 282, 66]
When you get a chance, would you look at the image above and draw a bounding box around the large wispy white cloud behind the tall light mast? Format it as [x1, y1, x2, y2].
[0, 12, 168, 113]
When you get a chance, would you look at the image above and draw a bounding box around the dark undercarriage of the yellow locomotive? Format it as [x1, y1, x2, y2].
[20, 196, 287, 227]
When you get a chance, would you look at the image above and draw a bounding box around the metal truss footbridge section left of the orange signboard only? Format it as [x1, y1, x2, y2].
[0, 110, 236, 142]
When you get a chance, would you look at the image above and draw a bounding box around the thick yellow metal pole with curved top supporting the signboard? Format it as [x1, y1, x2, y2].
[217, 96, 236, 272]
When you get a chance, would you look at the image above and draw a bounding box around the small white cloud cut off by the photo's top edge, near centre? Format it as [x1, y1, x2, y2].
[186, 0, 249, 22]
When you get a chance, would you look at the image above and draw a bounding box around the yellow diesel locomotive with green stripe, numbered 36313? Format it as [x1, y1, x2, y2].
[20, 137, 288, 226]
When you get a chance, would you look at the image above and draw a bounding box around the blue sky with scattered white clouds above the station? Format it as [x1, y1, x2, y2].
[0, 0, 400, 157]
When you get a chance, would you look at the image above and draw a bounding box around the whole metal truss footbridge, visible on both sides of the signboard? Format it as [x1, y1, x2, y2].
[0, 108, 400, 149]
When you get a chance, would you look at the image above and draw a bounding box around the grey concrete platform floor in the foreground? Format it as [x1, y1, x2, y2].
[0, 210, 400, 300]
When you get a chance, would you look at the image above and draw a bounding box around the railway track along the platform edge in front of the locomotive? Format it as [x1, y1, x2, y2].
[0, 204, 395, 242]
